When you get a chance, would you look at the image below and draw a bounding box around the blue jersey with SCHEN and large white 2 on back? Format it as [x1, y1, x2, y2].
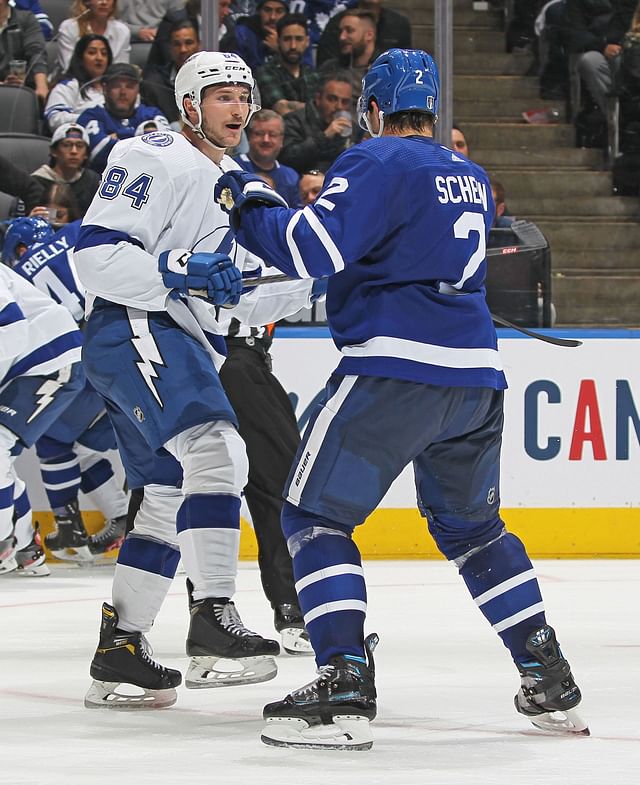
[232, 136, 506, 389]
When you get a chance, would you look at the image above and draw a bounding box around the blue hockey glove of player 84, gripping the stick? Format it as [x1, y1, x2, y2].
[158, 250, 242, 305]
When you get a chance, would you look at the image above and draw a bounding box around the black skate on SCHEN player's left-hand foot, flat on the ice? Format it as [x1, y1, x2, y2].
[261, 633, 378, 750]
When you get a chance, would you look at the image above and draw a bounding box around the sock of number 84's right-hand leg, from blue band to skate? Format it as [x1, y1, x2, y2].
[176, 493, 240, 600]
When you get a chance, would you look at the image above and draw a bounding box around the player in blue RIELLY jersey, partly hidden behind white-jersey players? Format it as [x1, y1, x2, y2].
[3, 218, 128, 563]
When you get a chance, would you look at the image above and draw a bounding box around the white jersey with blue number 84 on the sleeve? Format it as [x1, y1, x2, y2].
[74, 131, 311, 365]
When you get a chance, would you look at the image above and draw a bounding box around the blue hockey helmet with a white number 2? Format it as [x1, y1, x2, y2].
[358, 49, 440, 136]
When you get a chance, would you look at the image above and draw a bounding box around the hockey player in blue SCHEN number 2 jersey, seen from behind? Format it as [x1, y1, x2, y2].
[216, 49, 588, 749]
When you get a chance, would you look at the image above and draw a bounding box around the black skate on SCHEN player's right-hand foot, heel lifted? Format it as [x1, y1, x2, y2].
[514, 627, 589, 736]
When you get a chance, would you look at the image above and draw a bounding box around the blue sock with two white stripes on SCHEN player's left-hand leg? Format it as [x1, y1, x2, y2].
[282, 502, 367, 666]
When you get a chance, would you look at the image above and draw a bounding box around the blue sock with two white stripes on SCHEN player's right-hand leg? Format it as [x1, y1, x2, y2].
[460, 533, 546, 663]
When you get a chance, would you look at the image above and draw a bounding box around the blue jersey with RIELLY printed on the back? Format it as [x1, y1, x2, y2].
[13, 221, 84, 323]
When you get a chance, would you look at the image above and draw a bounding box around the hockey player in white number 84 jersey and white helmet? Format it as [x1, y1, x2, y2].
[75, 52, 322, 708]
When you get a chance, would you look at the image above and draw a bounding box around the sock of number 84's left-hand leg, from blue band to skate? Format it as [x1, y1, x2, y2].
[113, 533, 180, 632]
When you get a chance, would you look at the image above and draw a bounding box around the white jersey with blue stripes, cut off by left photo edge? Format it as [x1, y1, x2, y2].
[0, 264, 82, 385]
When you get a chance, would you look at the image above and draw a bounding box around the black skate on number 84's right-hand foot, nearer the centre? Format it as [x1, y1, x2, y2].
[184, 579, 280, 689]
